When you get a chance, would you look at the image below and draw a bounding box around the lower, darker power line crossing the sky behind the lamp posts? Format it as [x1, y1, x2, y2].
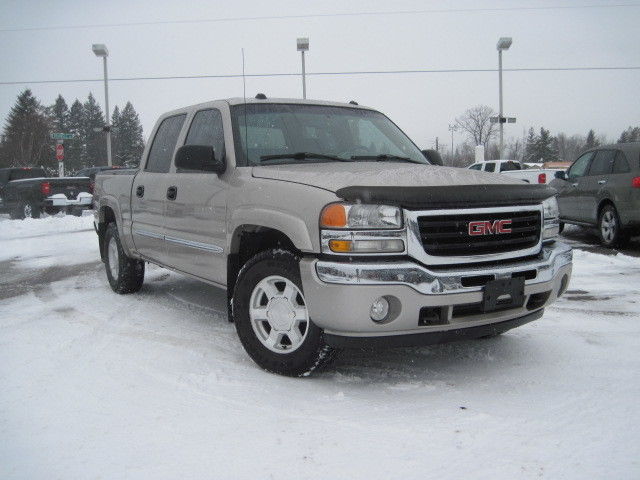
[0, 66, 640, 85]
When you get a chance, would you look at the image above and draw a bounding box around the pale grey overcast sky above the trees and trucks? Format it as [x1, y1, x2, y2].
[0, 0, 640, 154]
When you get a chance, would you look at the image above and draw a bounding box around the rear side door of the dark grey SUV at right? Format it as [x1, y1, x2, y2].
[578, 150, 616, 224]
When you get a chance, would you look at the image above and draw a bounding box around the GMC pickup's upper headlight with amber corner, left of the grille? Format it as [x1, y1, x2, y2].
[320, 203, 402, 230]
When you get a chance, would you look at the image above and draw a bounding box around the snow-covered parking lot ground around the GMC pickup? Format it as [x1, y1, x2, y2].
[0, 216, 640, 480]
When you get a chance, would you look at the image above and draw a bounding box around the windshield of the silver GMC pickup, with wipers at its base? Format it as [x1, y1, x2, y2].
[231, 103, 428, 166]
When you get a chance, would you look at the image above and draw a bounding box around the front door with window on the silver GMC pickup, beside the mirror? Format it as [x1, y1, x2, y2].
[165, 108, 228, 285]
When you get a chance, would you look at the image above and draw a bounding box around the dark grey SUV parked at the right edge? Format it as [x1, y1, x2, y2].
[551, 142, 640, 247]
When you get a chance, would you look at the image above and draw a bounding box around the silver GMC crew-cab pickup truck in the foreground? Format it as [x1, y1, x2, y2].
[94, 94, 572, 376]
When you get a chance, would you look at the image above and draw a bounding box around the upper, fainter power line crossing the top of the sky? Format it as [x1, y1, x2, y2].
[0, 3, 640, 32]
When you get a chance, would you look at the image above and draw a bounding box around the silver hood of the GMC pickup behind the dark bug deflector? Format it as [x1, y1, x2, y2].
[252, 162, 524, 192]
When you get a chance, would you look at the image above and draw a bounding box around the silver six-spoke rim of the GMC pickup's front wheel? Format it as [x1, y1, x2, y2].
[249, 275, 309, 353]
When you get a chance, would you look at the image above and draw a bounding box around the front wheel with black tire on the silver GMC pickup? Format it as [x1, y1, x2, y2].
[232, 250, 335, 377]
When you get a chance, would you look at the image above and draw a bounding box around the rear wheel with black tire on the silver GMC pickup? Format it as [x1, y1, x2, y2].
[104, 223, 144, 294]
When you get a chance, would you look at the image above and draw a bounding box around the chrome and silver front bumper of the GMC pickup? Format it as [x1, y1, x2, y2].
[300, 242, 572, 337]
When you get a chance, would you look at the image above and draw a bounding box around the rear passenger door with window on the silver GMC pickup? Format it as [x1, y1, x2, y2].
[131, 114, 186, 263]
